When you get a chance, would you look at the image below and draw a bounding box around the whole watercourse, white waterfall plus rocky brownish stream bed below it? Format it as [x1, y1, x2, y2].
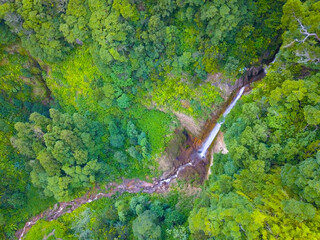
[16, 66, 261, 240]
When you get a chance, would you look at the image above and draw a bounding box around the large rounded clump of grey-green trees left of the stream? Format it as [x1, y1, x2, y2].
[13, 109, 103, 200]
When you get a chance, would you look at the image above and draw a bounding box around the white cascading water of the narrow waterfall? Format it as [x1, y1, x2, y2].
[198, 87, 244, 158]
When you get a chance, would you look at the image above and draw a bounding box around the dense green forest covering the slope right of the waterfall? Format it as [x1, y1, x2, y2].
[189, 0, 320, 239]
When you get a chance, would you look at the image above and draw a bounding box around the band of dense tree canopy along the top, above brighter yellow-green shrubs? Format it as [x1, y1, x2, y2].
[1, 0, 284, 75]
